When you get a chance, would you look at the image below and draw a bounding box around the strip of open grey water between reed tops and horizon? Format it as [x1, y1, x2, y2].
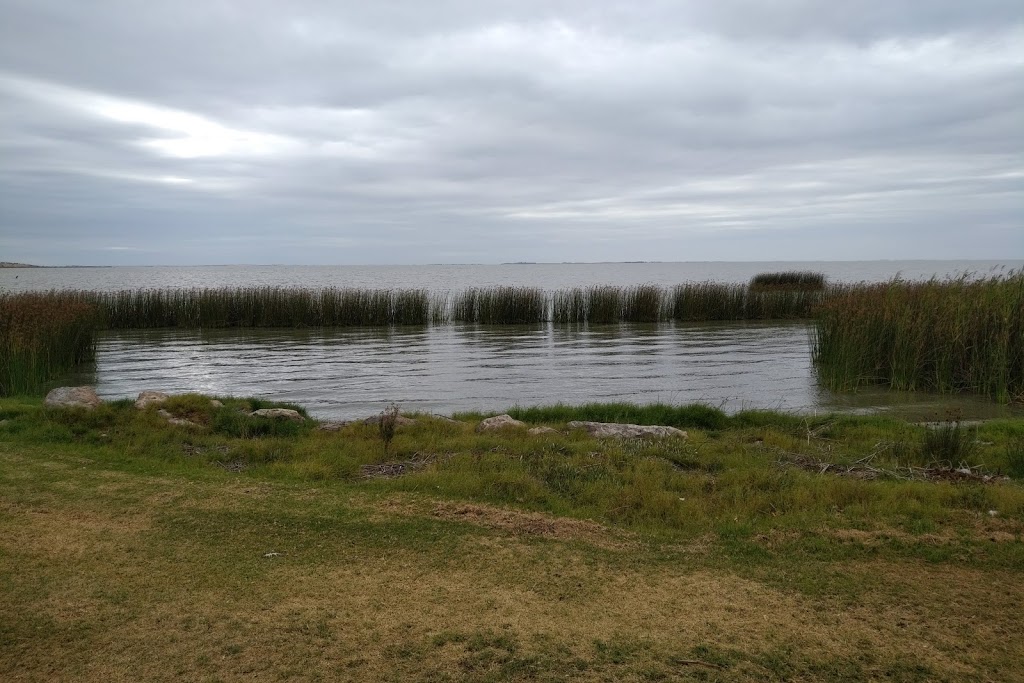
[0, 260, 1024, 291]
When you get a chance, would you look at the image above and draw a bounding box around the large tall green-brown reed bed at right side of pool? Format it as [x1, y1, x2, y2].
[813, 272, 1024, 401]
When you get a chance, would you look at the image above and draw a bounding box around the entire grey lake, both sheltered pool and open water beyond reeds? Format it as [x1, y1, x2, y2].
[12, 261, 1024, 419]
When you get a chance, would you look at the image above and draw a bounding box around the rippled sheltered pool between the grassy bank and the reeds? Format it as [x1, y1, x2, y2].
[61, 324, 1005, 419]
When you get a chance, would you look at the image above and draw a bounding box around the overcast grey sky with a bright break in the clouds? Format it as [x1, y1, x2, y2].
[0, 0, 1024, 265]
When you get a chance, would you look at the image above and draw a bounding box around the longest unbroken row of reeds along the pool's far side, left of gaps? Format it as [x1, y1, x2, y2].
[81, 287, 431, 329]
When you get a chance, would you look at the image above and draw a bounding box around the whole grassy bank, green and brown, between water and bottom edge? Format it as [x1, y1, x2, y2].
[0, 396, 1024, 681]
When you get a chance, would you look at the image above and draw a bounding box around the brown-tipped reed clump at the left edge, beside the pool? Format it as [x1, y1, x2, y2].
[0, 292, 96, 395]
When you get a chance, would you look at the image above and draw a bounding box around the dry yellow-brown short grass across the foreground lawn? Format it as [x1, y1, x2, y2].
[0, 454, 1024, 681]
